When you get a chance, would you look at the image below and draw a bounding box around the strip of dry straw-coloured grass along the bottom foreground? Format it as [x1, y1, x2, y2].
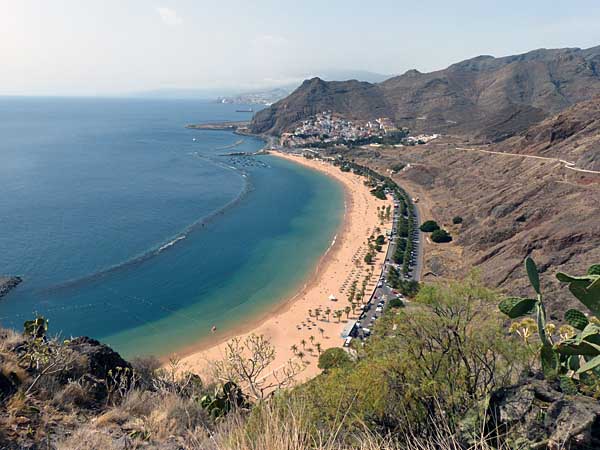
[51, 392, 520, 450]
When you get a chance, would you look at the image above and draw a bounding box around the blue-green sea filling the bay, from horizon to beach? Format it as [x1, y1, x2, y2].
[0, 99, 343, 356]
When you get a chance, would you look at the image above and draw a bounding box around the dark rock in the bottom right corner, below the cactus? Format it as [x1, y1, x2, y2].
[486, 378, 600, 450]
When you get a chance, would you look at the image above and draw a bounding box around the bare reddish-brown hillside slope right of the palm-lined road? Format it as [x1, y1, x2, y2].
[349, 99, 600, 320]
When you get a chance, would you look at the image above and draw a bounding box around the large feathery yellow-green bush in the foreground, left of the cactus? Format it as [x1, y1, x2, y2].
[264, 277, 525, 443]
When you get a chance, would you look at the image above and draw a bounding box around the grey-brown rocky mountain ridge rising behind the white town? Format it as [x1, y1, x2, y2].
[252, 46, 600, 141]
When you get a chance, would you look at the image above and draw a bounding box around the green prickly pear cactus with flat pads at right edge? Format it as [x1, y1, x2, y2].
[499, 257, 600, 384]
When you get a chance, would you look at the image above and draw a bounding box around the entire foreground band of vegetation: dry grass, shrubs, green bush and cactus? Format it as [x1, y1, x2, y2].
[0, 260, 600, 450]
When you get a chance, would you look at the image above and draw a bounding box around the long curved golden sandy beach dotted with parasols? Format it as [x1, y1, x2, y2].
[182, 152, 393, 381]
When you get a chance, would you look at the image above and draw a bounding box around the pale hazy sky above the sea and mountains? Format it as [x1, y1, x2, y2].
[0, 0, 600, 96]
